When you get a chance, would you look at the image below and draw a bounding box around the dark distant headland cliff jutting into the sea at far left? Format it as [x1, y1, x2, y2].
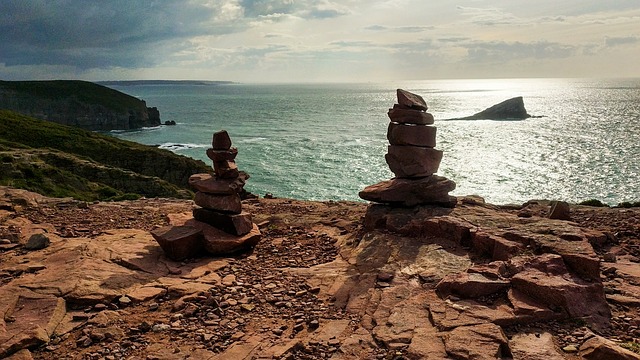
[0, 80, 160, 131]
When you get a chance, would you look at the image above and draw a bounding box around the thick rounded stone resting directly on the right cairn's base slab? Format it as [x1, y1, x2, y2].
[384, 145, 442, 178]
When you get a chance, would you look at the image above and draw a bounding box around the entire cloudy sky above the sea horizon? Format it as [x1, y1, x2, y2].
[0, 0, 640, 83]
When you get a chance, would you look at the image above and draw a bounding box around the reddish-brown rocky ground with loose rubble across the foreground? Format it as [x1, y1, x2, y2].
[0, 188, 640, 359]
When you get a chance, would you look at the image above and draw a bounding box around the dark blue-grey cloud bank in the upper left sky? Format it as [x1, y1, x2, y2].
[0, 0, 245, 69]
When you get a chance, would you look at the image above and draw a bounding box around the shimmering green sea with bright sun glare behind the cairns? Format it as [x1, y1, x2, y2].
[110, 79, 640, 205]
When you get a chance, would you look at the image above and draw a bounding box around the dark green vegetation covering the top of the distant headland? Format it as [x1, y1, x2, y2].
[0, 80, 145, 112]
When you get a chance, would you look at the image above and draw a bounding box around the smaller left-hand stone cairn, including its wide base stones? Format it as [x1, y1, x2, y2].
[151, 130, 262, 260]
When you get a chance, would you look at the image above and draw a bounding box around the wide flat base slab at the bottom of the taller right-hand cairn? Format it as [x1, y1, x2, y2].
[358, 175, 456, 207]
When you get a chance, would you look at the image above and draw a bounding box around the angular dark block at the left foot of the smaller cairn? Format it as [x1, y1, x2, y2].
[151, 226, 203, 261]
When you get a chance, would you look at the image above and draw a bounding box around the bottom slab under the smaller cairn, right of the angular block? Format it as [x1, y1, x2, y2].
[185, 219, 262, 255]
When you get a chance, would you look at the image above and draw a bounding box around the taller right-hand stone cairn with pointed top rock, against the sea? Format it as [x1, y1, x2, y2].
[359, 89, 457, 207]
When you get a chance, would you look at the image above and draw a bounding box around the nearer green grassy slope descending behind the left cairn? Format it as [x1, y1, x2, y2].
[0, 110, 210, 200]
